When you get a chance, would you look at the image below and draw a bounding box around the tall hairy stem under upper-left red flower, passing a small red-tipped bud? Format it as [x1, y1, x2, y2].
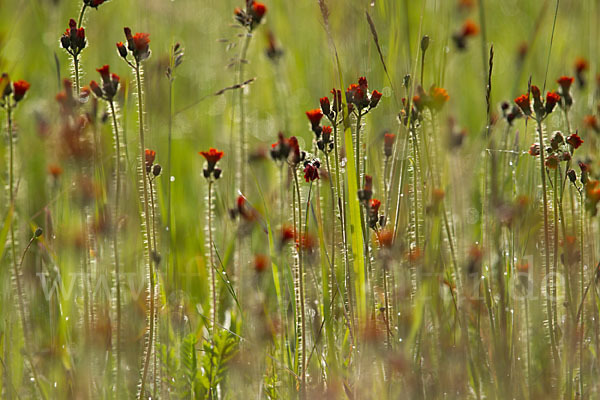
[135, 62, 154, 399]
